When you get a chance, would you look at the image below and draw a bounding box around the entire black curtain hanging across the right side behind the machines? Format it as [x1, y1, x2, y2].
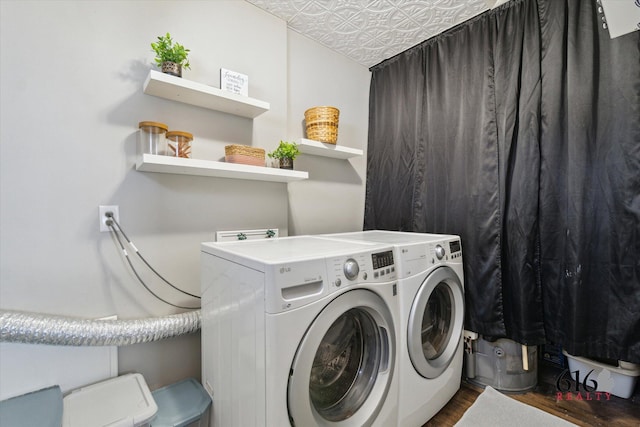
[364, 0, 640, 362]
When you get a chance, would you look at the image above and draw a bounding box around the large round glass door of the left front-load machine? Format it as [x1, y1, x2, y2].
[287, 289, 395, 426]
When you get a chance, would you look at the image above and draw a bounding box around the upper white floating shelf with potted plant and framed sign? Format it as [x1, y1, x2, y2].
[143, 70, 270, 119]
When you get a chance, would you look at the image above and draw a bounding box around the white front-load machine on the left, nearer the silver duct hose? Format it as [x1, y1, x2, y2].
[202, 236, 399, 427]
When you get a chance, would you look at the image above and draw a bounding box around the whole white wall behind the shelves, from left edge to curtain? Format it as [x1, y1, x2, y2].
[0, 0, 369, 396]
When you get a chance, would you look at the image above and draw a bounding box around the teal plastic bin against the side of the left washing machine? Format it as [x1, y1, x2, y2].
[151, 378, 211, 427]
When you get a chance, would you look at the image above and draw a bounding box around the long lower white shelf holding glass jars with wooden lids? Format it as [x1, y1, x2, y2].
[136, 154, 309, 182]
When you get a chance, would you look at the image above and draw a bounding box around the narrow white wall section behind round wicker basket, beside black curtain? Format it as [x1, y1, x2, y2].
[288, 31, 370, 234]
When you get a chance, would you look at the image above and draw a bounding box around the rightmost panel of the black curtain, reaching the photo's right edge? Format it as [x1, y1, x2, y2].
[539, 0, 640, 363]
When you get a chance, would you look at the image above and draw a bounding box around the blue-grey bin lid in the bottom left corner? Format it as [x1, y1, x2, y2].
[0, 386, 62, 427]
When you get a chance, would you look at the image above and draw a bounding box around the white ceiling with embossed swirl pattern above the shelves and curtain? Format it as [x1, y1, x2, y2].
[242, 0, 498, 67]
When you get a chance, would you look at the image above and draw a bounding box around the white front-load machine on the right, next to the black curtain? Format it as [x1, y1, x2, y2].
[328, 230, 464, 427]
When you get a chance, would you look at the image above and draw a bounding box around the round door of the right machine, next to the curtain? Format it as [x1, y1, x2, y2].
[407, 267, 464, 378]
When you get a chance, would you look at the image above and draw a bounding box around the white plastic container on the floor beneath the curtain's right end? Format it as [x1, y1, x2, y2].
[562, 350, 640, 399]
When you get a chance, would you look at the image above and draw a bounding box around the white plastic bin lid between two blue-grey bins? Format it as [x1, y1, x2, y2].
[62, 374, 158, 427]
